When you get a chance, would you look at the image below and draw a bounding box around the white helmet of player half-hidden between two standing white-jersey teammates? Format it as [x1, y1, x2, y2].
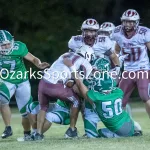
[98, 22, 115, 36]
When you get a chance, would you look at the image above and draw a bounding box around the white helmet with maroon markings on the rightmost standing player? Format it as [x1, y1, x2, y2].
[121, 9, 140, 30]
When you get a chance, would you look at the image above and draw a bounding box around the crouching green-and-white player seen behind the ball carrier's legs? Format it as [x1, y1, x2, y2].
[27, 99, 71, 139]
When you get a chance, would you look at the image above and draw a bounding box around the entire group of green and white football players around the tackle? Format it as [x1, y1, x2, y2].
[0, 9, 150, 141]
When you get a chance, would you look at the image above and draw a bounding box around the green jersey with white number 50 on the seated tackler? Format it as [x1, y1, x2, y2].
[88, 88, 130, 132]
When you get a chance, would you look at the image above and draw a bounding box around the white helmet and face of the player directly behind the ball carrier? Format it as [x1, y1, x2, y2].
[81, 18, 99, 46]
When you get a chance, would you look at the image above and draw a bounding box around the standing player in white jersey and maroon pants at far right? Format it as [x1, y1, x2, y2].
[112, 9, 150, 119]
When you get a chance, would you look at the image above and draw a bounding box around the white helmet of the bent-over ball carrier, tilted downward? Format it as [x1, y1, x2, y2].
[76, 45, 95, 62]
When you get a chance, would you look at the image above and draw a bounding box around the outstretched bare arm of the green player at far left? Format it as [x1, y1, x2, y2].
[24, 52, 50, 69]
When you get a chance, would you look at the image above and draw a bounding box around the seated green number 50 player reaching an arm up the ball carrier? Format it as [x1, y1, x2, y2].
[64, 59, 142, 137]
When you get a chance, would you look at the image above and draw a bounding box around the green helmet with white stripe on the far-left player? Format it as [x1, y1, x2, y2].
[0, 30, 14, 55]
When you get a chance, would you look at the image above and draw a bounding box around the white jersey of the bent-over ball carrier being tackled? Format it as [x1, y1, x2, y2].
[44, 52, 92, 84]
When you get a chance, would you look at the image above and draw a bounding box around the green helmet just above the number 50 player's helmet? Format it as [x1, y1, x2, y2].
[92, 58, 110, 72]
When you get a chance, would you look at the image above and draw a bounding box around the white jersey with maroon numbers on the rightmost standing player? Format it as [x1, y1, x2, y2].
[113, 25, 150, 71]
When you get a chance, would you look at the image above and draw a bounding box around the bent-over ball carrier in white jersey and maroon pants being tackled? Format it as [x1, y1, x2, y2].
[35, 45, 94, 140]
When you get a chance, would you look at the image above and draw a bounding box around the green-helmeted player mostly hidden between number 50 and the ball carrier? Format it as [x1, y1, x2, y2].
[83, 58, 110, 138]
